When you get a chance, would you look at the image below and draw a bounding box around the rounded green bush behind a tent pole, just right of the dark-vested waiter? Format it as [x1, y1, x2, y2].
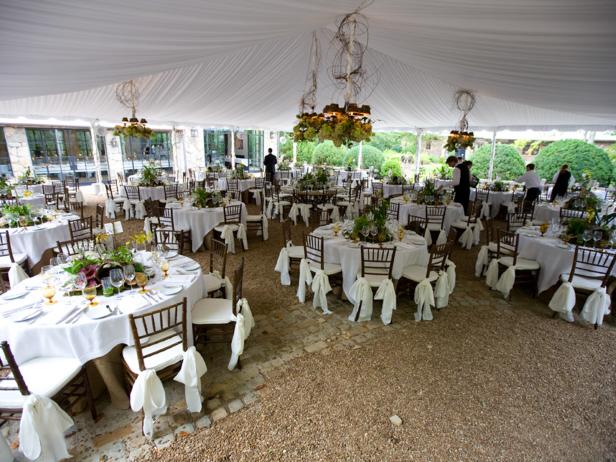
[470, 143, 526, 180]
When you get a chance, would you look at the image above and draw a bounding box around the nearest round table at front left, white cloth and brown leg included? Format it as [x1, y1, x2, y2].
[0, 253, 204, 407]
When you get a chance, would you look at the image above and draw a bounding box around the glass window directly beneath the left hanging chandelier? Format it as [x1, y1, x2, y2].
[120, 132, 173, 176]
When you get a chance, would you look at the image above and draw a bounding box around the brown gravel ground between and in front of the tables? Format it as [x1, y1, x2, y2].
[115, 205, 616, 461]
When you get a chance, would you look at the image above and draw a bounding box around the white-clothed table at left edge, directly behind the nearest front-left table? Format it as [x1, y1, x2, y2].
[8, 213, 79, 267]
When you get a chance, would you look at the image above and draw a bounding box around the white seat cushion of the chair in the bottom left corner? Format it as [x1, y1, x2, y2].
[0, 357, 81, 409]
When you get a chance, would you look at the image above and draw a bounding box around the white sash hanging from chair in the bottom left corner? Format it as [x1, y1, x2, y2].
[19, 395, 74, 462]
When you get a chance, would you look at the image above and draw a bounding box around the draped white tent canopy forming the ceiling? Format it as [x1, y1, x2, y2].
[0, 0, 616, 130]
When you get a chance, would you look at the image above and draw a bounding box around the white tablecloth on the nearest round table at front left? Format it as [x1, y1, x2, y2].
[0, 253, 203, 364]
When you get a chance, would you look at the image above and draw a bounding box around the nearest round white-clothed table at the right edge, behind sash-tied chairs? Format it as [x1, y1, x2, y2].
[518, 226, 616, 293]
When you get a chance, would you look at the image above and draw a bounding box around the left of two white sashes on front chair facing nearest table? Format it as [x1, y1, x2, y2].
[130, 369, 167, 439]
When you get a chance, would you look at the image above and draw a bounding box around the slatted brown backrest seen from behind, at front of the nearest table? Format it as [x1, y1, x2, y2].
[128, 297, 188, 371]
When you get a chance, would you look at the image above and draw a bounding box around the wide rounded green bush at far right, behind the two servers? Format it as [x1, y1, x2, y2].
[535, 140, 614, 185]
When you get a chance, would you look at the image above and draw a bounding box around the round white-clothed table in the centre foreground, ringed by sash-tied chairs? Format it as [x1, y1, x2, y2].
[312, 225, 429, 303]
